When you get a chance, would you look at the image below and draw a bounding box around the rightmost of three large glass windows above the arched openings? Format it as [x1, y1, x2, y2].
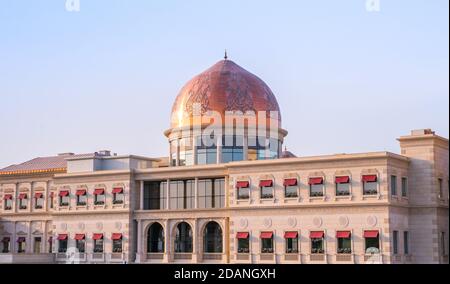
[198, 179, 225, 209]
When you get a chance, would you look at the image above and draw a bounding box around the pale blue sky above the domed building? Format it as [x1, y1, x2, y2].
[0, 0, 449, 168]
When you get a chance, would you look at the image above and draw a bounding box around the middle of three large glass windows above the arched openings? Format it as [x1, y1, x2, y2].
[169, 180, 195, 209]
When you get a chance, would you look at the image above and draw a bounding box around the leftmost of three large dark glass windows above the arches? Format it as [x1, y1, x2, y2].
[144, 181, 167, 210]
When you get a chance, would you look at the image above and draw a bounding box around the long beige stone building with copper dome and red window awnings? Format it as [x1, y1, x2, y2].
[0, 59, 449, 264]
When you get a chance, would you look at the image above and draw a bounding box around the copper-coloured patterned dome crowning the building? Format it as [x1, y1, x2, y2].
[171, 60, 281, 128]
